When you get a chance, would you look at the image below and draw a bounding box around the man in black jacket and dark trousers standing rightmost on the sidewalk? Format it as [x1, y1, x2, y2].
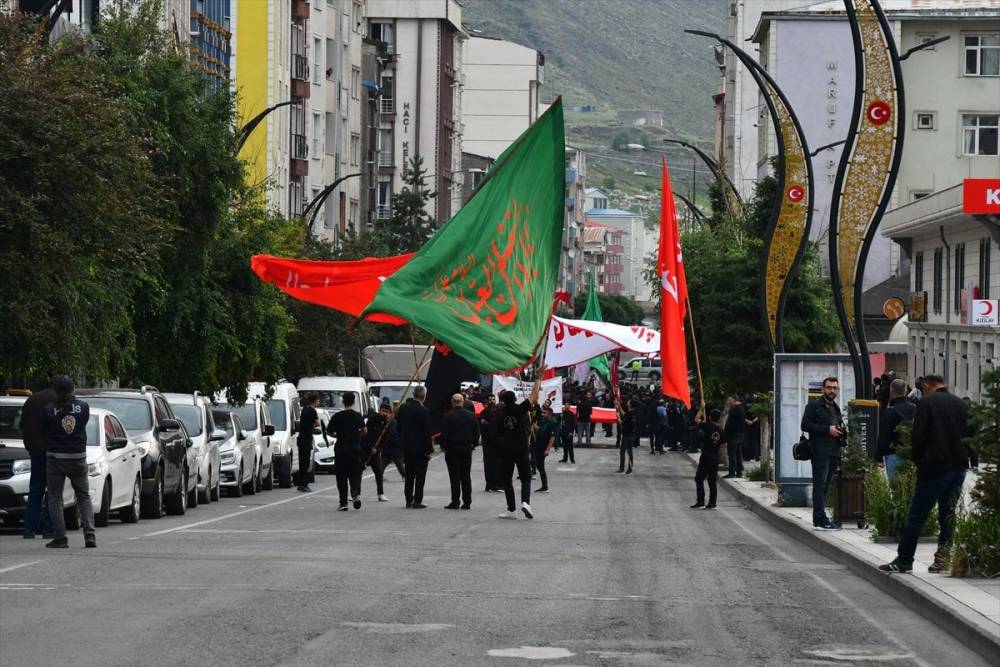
[879, 375, 972, 572]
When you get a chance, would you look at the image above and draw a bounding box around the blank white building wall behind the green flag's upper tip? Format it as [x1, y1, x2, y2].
[462, 35, 545, 158]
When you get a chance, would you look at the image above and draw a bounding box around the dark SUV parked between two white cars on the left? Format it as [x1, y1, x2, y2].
[76, 385, 198, 519]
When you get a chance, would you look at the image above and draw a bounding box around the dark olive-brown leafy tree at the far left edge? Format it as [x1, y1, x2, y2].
[0, 11, 166, 382]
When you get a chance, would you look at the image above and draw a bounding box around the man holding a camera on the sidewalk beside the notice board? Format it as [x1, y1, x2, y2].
[801, 377, 846, 530]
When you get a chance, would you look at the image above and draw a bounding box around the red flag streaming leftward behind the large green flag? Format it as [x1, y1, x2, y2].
[250, 254, 413, 325]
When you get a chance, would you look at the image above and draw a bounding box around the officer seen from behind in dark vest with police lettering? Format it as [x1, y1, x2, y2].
[43, 375, 97, 549]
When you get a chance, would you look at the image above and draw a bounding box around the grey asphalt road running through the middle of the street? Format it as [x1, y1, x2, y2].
[0, 438, 984, 667]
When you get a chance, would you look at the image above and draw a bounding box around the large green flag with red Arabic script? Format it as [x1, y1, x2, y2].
[361, 100, 566, 372]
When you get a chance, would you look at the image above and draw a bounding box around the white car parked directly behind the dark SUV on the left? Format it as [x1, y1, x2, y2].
[164, 391, 225, 507]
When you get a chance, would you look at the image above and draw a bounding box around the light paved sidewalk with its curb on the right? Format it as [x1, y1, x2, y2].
[686, 454, 1000, 665]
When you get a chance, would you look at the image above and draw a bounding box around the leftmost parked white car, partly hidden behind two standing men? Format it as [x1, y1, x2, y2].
[0, 396, 80, 530]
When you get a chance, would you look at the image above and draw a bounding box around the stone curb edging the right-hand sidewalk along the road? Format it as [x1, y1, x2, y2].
[689, 457, 1000, 666]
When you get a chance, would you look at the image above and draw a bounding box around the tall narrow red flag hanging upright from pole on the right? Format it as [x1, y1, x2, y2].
[656, 156, 691, 408]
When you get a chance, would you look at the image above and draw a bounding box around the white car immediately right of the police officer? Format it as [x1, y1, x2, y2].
[87, 409, 142, 528]
